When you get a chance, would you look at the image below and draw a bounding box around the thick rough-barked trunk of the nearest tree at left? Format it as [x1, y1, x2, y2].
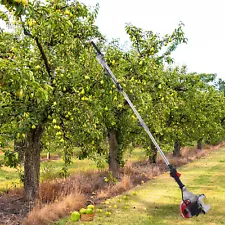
[24, 125, 43, 201]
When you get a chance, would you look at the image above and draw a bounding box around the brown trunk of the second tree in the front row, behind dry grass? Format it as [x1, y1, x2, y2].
[108, 130, 120, 176]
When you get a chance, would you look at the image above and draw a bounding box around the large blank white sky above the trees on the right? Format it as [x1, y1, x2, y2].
[80, 0, 225, 80]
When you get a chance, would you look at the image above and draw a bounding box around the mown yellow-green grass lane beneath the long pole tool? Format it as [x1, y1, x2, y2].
[54, 147, 225, 225]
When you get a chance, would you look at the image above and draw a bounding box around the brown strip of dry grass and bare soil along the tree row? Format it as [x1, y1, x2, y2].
[0, 143, 225, 225]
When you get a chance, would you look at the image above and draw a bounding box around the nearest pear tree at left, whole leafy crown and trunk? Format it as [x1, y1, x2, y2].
[0, 0, 100, 200]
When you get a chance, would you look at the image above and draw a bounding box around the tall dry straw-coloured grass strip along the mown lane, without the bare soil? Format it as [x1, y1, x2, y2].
[18, 142, 225, 225]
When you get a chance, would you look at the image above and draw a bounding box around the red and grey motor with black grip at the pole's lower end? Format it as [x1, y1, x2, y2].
[169, 165, 210, 218]
